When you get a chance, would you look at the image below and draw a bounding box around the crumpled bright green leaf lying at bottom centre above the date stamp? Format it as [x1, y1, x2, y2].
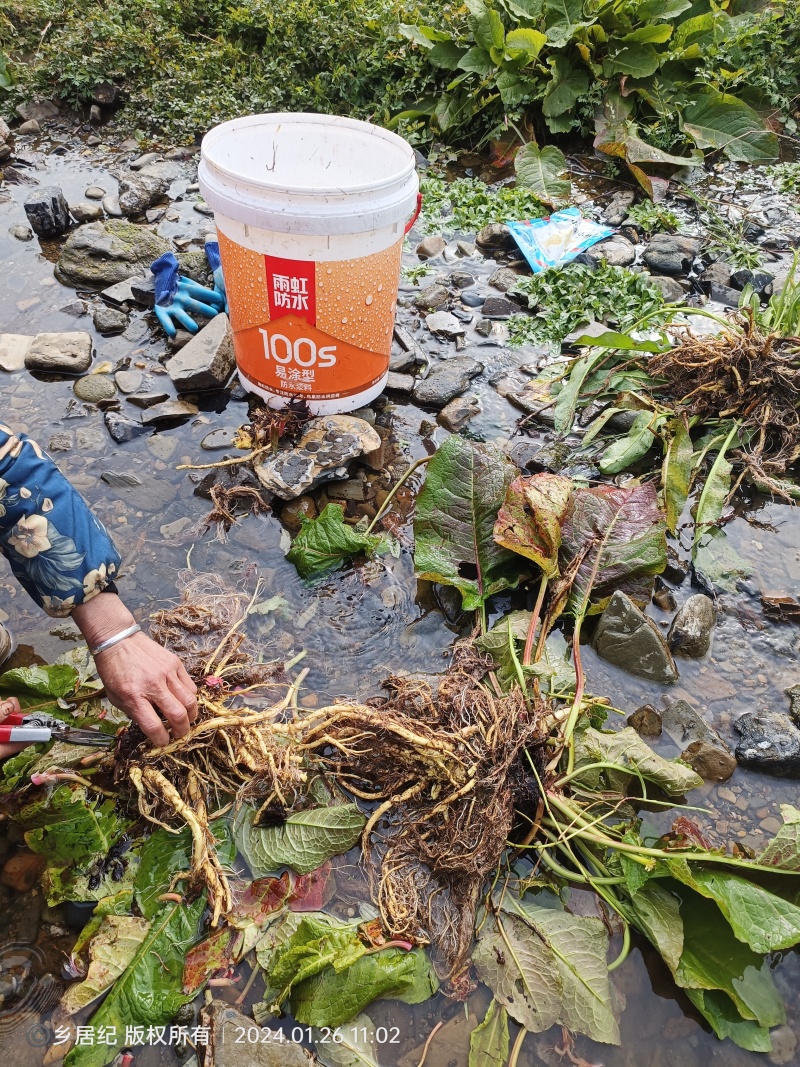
[290, 949, 438, 1026]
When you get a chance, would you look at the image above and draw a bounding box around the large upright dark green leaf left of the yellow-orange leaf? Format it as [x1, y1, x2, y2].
[414, 434, 524, 610]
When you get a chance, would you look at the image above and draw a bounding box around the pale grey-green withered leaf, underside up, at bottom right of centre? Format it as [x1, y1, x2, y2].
[473, 898, 620, 1045]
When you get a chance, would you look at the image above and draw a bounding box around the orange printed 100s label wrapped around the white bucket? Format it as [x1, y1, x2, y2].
[220, 234, 402, 400]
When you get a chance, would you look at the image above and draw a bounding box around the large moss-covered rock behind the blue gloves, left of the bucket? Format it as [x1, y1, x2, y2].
[57, 219, 170, 288]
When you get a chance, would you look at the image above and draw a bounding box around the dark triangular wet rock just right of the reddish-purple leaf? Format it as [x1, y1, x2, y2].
[594, 590, 677, 683]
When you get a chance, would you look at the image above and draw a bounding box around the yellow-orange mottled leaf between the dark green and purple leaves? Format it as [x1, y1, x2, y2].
[494, 474, 572, 578]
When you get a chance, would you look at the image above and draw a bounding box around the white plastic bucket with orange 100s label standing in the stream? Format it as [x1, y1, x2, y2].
[198, 114, 419, 415]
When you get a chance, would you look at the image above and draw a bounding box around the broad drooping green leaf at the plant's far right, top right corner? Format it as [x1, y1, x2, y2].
[683, 89, 779, 163]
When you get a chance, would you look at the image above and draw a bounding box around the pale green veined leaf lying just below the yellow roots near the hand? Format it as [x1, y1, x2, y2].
[234, 803, 367, 878]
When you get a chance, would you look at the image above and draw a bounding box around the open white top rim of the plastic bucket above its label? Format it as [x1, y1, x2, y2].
[198, 112, 418, 235]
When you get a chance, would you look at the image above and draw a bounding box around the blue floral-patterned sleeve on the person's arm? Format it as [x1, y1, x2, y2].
[0, 426, 119, 617]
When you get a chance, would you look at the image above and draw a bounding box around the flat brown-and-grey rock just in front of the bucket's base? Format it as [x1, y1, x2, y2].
[254, 415, 381, 500]
